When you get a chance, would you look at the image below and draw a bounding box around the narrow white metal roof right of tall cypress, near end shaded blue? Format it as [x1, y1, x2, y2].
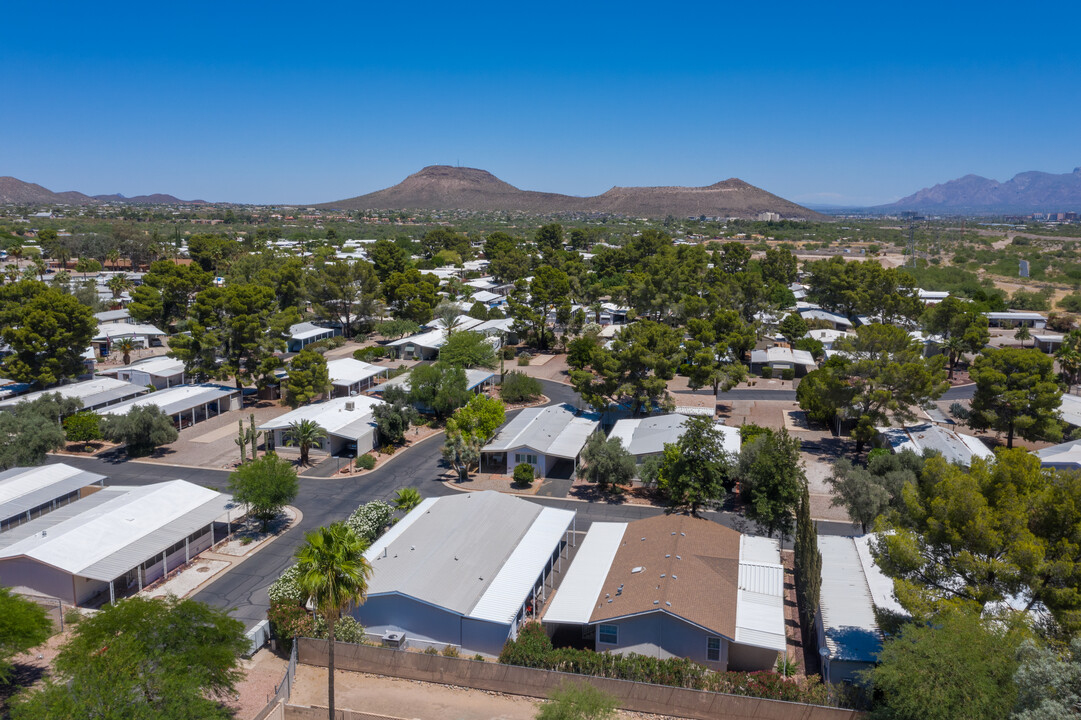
[818, 535, 882, 663]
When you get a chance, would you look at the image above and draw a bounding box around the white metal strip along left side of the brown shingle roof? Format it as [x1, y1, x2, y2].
[542, 522, 627, 625]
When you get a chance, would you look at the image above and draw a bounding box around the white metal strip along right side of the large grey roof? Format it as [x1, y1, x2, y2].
[469, 507, 574, 624]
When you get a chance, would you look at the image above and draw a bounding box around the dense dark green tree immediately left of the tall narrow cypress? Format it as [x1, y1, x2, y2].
[737, 429, 806, 537]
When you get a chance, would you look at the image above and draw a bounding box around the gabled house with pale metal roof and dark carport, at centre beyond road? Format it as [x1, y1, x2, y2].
[480, 404, 600, 478]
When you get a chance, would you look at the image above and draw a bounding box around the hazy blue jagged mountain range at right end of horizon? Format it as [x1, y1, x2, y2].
[872, 168, 1081, 214]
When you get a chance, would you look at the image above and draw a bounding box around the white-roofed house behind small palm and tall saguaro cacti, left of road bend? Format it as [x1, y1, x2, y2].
[257, 395, 383, 455]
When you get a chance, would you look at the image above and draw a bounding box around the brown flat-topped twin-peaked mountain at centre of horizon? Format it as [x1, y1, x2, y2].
[317, 165, 818, 218]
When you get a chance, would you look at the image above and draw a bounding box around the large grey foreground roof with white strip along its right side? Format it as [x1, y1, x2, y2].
[365, 491, 574, 623]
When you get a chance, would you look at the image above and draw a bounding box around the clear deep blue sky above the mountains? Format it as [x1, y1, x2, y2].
[0, 0, 1081, 203]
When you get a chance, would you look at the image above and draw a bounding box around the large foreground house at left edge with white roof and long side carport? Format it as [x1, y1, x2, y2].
[0, 480, 237, 605]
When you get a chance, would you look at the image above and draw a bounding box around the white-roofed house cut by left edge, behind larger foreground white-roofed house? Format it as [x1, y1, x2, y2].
[0, 463, 105, 533]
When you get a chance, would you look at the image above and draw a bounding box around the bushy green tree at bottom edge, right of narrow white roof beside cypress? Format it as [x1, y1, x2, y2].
[867, 613, 1024, 720]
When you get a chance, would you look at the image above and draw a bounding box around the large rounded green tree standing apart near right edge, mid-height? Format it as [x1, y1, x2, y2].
[969, 347, 1063, 448]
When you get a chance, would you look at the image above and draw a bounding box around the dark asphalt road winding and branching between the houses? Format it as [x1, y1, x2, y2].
[42, 381, 855, 627]
